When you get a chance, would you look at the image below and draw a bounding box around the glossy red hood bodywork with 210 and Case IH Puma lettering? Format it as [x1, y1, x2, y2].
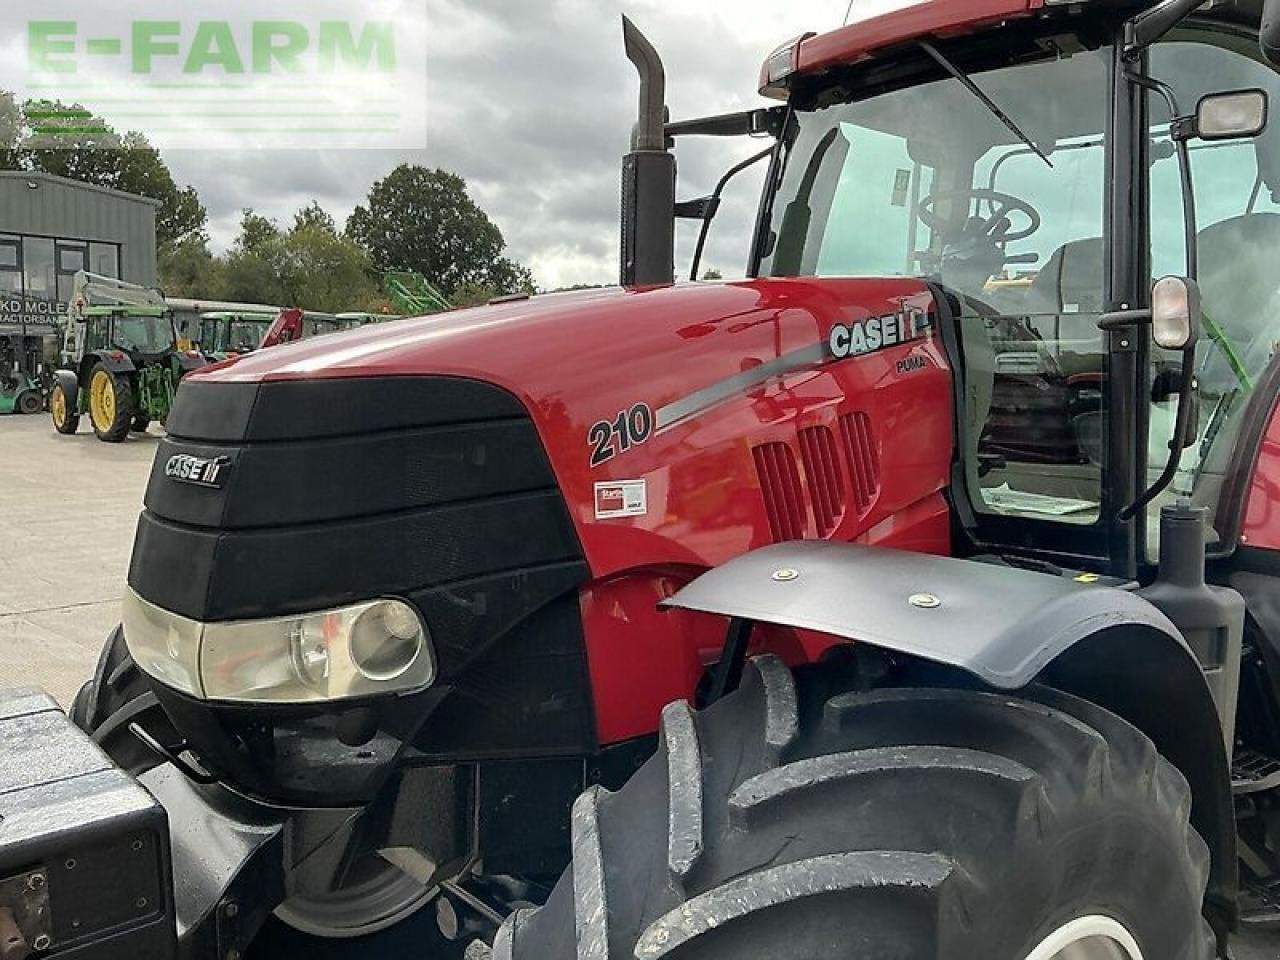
[193, 279, 952, 742]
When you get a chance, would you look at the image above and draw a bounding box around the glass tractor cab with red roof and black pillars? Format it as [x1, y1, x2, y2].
[623, 0, 1280, 576]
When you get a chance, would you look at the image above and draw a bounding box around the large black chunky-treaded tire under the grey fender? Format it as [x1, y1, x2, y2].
[504, 658, 1215, 960]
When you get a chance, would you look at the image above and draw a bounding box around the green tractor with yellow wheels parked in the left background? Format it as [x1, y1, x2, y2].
[49, 271, 207, 443]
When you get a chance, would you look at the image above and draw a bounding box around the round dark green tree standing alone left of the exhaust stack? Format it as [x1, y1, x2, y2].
[347, 164, 532, 298]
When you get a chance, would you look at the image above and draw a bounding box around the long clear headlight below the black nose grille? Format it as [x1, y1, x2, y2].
[124, 590, 435, 703]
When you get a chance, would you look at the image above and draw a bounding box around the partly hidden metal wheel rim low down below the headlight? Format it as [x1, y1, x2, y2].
[275, 854, 436, 940]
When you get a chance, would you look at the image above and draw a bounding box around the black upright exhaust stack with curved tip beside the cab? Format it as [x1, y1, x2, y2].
[621, 17, 676, 287]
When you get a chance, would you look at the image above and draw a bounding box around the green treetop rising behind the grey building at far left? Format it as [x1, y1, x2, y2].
[0, 92, 209, 247]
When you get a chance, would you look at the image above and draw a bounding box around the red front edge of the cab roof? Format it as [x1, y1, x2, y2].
[799, 0, 1044, 73]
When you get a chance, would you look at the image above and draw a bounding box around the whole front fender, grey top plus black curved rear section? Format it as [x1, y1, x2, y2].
[663, 541, 1238, 942]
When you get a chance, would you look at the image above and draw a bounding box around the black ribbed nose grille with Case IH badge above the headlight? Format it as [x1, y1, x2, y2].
[129, 378, 585, 621]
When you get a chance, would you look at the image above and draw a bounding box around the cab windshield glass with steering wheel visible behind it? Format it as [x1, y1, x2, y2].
[762, 50, 1111, 524]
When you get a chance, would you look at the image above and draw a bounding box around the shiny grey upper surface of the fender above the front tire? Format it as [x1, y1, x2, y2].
[666, 541, 1194, 690]
